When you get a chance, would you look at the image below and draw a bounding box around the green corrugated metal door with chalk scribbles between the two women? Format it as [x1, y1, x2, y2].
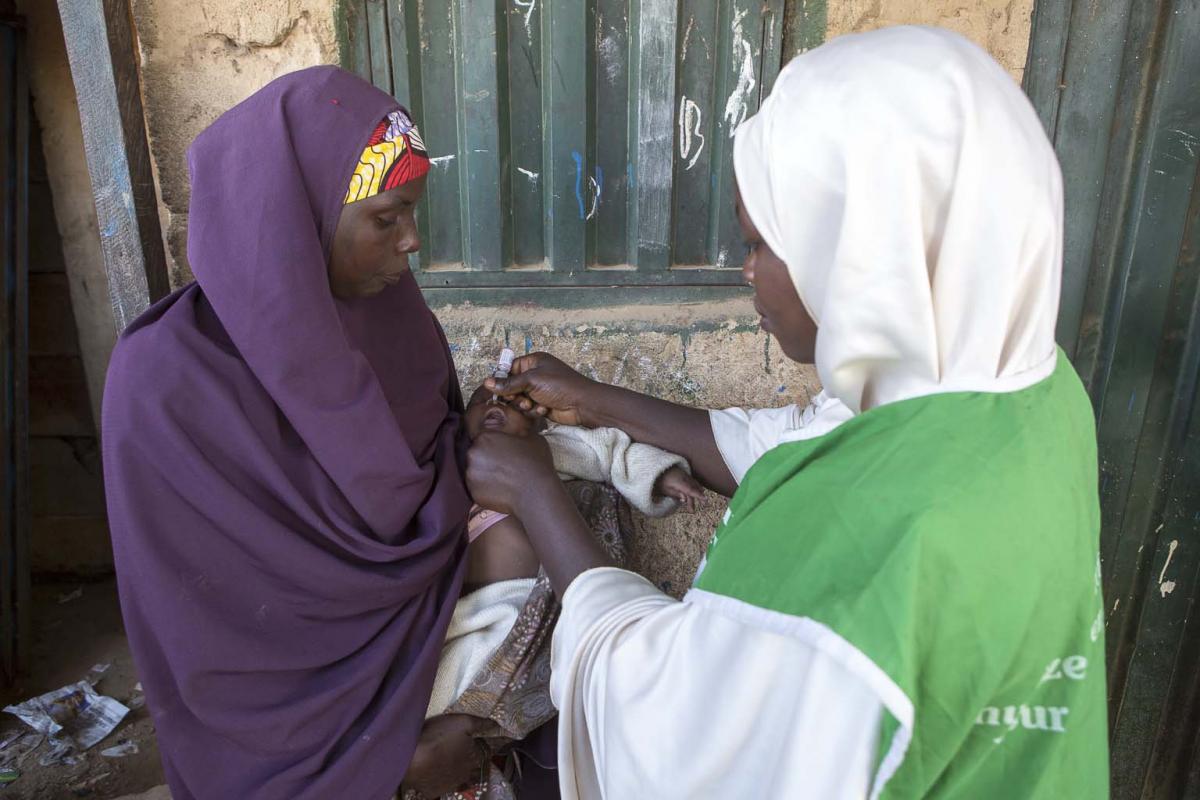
[344, 0, 784, 302]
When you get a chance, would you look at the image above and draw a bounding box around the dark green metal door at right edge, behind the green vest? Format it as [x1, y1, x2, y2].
[1026, 0, 1200, 799]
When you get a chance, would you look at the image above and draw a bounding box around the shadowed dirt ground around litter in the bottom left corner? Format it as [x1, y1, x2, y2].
[0, 579, 169, 800]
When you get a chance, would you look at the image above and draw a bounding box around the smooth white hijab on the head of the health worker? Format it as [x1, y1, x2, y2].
[733, 28, 1062, 413]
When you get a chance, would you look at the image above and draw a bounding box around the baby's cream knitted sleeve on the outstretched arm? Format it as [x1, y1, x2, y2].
[542, 425, 691, 517]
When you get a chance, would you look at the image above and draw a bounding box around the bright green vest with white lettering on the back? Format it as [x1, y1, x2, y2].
[696, 354, 1109, 799]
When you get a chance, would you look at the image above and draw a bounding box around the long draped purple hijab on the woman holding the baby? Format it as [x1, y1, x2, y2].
[103, 67, 470, 800]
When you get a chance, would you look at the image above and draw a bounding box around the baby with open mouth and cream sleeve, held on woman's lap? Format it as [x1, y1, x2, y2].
[417, 386, 703, 800]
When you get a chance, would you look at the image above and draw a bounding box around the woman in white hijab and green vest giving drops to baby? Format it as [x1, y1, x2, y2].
[468, 28, 1108, 800]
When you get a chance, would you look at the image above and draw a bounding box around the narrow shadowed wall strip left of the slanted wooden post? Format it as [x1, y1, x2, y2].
[18, 0, 116, 576]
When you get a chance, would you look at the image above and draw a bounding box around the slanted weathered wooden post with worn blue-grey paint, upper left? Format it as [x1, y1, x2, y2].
[59, 0, 169, 331]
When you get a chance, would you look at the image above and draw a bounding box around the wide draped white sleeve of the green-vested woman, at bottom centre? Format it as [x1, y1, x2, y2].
[551, 569, 882, 800]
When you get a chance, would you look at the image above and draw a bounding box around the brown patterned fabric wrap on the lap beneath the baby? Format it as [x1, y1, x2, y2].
[401, 481, 634, 800]
